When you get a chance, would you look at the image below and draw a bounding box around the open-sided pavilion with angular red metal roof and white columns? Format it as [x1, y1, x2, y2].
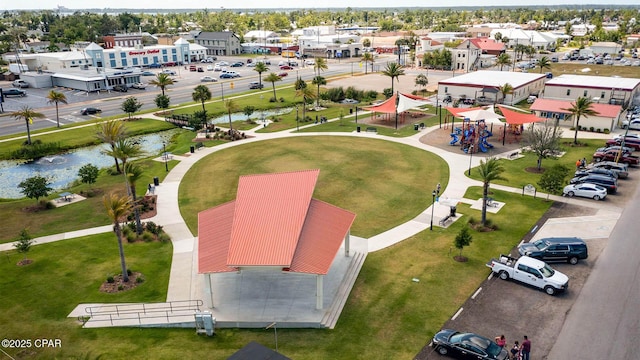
[198, 170, 356, 322]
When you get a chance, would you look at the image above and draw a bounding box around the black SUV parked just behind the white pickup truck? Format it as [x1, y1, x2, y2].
[518, 237, 589, 265]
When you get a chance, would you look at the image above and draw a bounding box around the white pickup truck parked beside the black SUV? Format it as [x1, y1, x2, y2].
[487, 255, 569, 295]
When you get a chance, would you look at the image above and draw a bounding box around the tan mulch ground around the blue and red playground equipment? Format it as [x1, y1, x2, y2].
[420, 124, 521, 157]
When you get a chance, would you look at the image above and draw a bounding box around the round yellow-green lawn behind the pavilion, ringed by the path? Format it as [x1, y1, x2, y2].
[179, 136, 449, 237]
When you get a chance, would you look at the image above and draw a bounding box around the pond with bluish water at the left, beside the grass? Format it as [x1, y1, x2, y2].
[0, 129, 182, 199]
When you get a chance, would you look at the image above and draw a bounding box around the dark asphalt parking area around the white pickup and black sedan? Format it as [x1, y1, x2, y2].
[415, 239, 607, 360]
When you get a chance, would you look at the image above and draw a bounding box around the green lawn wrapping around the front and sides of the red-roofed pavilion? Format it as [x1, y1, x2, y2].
[0, 187, 551, 360]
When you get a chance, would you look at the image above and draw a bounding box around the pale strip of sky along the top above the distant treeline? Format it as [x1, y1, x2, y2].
[5, 0, 640, 12]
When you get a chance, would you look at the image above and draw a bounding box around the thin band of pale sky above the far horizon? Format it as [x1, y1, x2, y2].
[5, 0, 638, 10]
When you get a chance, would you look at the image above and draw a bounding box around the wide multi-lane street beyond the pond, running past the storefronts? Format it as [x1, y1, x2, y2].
[0, 57, 392, 136]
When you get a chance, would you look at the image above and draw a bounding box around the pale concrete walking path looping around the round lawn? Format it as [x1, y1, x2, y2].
[0, 113, 621, 330]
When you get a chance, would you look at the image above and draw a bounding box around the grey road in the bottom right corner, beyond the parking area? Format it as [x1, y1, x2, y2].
[548, 179, 640, 360]
